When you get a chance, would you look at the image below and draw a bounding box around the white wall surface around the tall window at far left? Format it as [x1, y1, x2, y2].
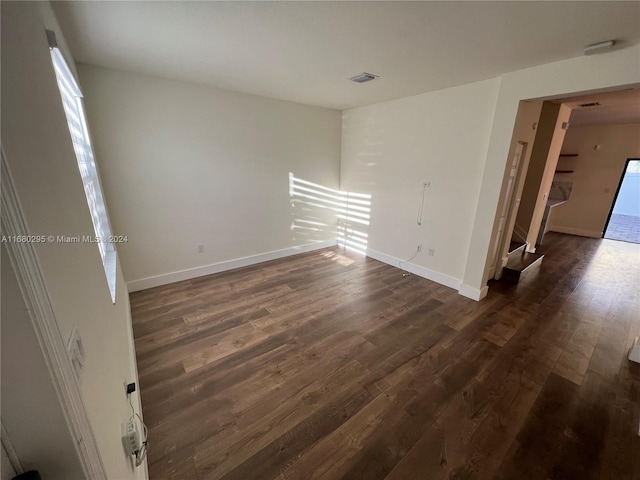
[1, 2, 145, 480]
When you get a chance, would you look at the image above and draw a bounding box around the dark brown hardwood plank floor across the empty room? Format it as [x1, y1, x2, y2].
[131, 233, 640, 480]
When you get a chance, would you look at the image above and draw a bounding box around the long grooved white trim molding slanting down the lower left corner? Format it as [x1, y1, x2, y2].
[0, 147, 107, 480]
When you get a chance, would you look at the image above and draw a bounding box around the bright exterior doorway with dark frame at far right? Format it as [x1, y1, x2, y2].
[603, 158, 640, 243]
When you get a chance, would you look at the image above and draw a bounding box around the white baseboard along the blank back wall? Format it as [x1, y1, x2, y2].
[127, 240, 337, 292]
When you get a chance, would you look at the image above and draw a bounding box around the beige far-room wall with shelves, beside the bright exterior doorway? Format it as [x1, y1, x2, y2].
[549, 124, 640, 238]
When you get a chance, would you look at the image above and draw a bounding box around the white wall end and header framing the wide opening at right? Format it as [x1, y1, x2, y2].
[463, 45, 640, 298]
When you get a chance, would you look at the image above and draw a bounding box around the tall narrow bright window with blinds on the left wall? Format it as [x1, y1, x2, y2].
[47, 30, 116, 303]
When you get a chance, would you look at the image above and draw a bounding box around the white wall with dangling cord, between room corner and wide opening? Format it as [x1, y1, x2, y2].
[340, 79, 500, 288]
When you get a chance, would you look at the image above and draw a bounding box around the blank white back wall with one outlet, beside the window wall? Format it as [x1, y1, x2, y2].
[78, 65, 340, 289]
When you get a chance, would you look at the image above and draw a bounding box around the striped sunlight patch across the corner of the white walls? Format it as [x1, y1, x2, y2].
[289, 173, 371, 254]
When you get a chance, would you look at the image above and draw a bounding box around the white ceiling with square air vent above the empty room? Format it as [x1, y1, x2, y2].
[52, 1, 640, 109]
